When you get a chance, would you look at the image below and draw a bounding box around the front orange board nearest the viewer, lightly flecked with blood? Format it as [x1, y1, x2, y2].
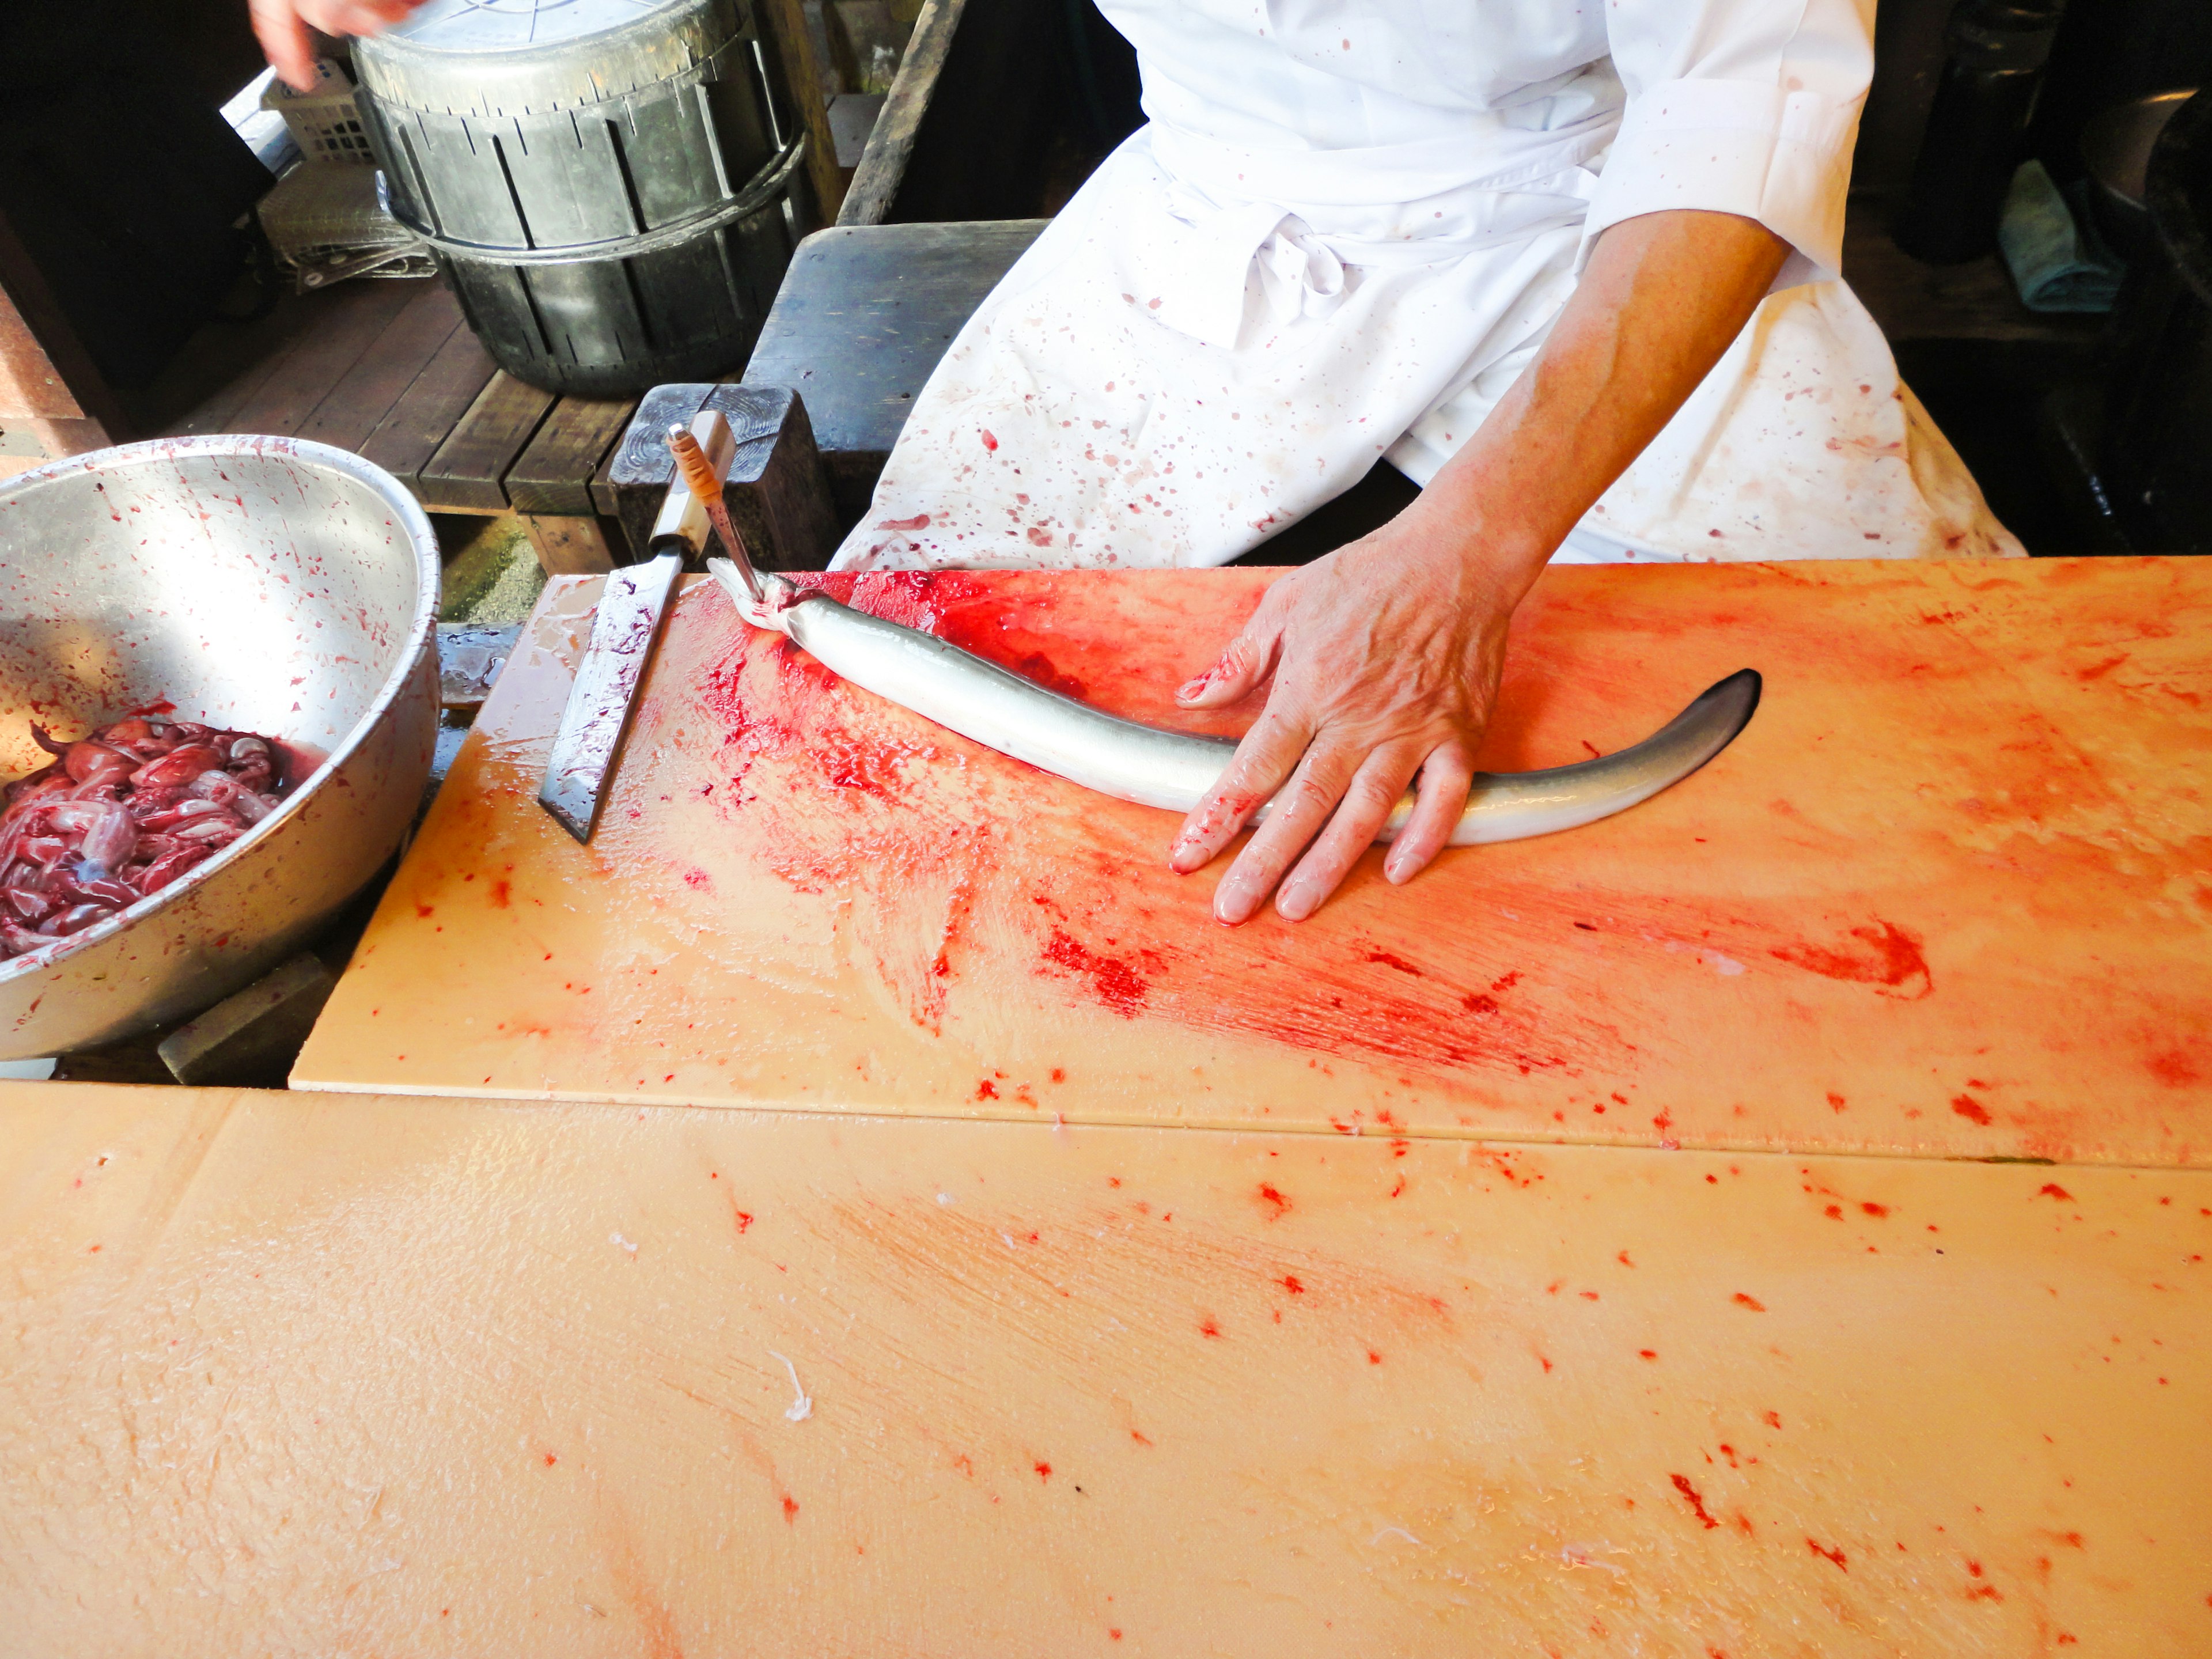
[0, 1086, 2212, 1659]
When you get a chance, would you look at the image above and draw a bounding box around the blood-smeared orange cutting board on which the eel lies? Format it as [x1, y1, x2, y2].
[294, 560, 2212, 1164]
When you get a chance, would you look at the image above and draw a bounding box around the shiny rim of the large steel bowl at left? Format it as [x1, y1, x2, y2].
[0, 434, 442, 984]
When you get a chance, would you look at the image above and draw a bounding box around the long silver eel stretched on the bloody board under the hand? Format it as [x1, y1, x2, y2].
[708, 560, 1759, 847]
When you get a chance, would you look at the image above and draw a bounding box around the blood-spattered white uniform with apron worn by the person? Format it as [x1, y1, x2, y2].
[834, 0, 2020, 569]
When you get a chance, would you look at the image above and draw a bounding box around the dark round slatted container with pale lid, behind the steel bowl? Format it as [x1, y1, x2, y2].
[354, 0, 819, 394]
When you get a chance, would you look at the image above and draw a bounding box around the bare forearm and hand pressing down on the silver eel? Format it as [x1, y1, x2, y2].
[1168, 210, 1790, 925]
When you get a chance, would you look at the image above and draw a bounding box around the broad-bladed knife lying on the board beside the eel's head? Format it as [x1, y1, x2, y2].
[537, 409, 734, 845]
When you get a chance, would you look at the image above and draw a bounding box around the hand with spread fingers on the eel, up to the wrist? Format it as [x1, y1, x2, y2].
[1168, 502, 1548, 927]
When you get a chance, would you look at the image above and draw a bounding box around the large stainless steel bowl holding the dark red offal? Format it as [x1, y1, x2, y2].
[0, 438, 438, 1059]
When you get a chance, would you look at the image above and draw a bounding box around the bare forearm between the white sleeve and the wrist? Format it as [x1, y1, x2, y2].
[1414, 210, 1790, 600]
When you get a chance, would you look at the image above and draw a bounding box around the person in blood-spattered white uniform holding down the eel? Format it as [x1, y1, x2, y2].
[256, 0, 2022, 922]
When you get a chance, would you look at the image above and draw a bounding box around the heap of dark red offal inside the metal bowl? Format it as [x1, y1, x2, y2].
[0, 714, 285, 958]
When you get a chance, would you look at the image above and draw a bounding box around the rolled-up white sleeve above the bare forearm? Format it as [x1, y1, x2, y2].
[1582, 0, 1873, 287]
